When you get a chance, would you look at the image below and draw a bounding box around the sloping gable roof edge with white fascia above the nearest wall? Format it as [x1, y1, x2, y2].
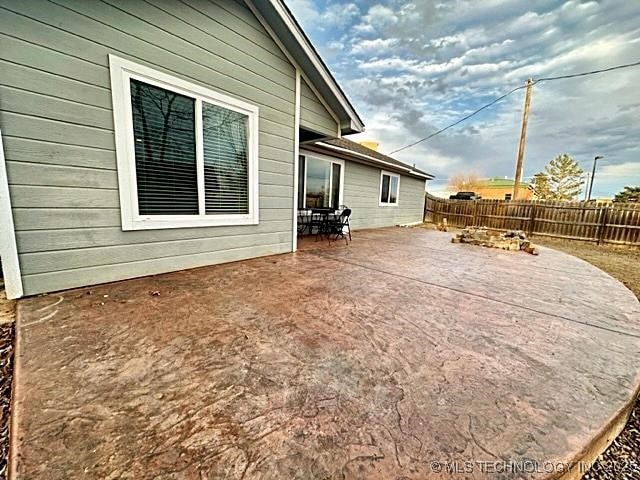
[245, 0, 364, 135]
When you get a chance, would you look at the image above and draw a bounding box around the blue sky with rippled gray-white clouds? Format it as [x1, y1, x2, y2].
[286, 0, 640, 196]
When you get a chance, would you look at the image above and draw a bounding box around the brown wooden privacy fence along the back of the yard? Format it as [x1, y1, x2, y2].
[424, 193, 640, 246]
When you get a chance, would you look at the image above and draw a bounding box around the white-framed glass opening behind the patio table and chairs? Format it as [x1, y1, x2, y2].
[298, 151, 344, 209]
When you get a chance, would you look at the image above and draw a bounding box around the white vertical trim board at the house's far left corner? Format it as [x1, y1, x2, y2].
[0, 132, 23, 299]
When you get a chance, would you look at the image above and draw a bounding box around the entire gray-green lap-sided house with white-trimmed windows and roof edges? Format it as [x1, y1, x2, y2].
[0, 0, 430, 297]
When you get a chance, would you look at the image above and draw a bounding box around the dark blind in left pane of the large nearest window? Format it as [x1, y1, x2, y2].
[130, 79, 198, 215]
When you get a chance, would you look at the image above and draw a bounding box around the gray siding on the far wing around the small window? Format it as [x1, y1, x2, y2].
[343, 161, 425, 229]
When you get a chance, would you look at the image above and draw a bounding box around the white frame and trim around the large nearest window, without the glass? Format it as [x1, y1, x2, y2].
[109, 55, 259, 230]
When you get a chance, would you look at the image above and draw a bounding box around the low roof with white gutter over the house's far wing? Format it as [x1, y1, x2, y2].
[304, 137, 434, 180]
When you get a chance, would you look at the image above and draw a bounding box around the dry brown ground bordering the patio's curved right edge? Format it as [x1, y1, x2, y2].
[532, 237, 640, 480]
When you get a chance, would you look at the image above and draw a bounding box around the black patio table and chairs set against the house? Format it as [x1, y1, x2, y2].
[298, 205, 351, 245]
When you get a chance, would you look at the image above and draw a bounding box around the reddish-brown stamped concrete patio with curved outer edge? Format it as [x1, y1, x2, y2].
[13, 228, 640, 480]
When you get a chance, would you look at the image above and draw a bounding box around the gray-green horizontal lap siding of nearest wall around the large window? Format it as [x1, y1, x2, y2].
[0, 0, 295, 294]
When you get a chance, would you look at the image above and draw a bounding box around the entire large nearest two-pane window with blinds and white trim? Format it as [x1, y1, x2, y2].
[109, 55, 259, 230]
